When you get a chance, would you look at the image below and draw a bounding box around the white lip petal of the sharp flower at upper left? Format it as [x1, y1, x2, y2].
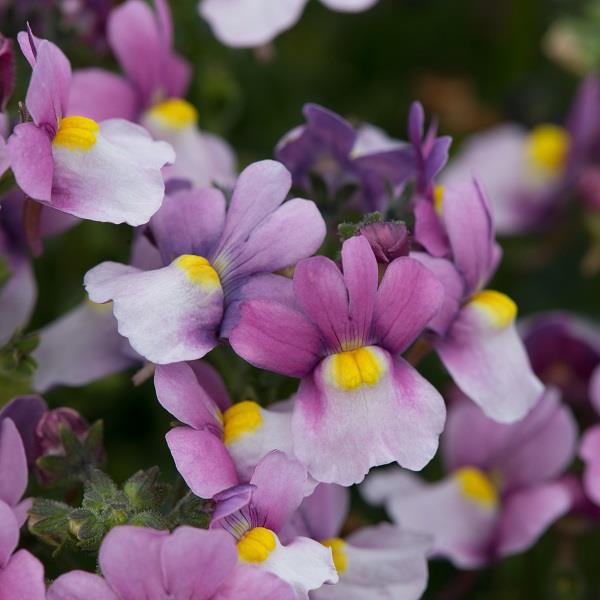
[51, 119, 175, 226]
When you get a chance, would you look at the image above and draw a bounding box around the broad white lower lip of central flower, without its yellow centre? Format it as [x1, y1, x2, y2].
[292, 347, 446, 486]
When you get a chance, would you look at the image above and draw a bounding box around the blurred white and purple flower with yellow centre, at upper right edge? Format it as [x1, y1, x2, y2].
[439, 79, 600, 235]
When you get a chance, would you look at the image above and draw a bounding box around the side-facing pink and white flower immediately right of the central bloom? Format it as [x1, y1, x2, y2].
[411, 180, 543, 422]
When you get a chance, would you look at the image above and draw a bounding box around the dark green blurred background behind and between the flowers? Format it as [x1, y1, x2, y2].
[0, 0, 600, 600]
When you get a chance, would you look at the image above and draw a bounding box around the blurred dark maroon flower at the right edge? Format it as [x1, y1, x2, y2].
[519, 312, 600, 408]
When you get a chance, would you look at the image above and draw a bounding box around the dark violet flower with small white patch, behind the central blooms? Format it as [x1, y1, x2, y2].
[275, 104, 413, 211]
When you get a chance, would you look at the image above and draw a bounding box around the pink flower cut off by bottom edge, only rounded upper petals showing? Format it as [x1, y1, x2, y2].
[47, 525, 294, 600]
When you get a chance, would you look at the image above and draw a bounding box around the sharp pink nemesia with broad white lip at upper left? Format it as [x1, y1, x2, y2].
[8, 32, 175, 225]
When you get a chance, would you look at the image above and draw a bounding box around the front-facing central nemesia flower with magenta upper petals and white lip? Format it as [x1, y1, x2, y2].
[229, 236, 445, 485]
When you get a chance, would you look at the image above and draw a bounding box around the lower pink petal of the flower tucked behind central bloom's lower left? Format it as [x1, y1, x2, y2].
[166, 427, 238, 498]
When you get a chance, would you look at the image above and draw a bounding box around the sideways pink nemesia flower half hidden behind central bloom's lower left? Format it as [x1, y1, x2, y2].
[154, 361, 308, 498]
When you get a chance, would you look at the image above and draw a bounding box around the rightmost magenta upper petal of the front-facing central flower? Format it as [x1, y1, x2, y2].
[375, 257, 444, 354]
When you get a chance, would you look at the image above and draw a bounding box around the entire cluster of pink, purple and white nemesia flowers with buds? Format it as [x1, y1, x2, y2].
[0, 0, 600, 600]
